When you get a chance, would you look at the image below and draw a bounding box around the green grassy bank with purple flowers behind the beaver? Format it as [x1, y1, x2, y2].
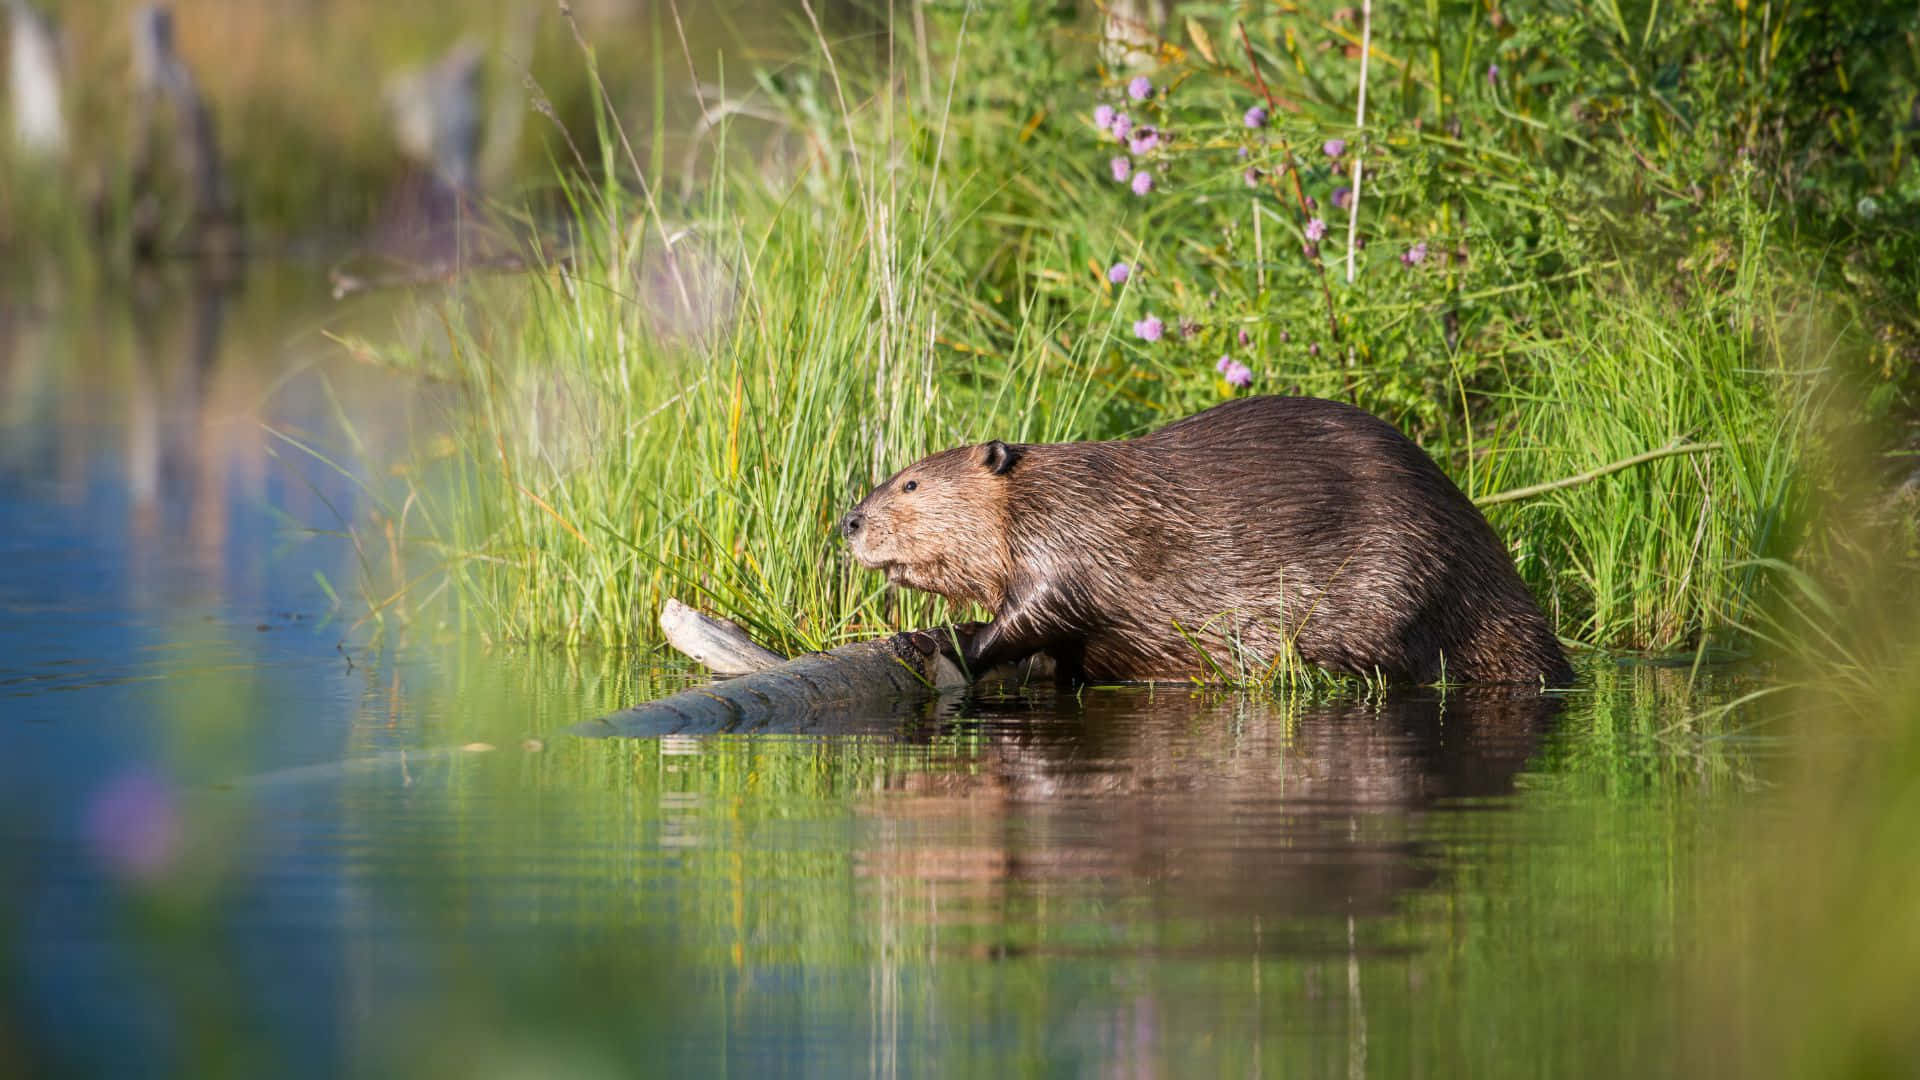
[357, 6, 1914, 651]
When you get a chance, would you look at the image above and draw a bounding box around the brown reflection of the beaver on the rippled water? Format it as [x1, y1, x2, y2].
[858, 690, 1559, 926]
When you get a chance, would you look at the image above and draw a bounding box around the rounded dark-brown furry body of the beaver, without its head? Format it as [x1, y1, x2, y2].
[1010, 398, 1571, 682]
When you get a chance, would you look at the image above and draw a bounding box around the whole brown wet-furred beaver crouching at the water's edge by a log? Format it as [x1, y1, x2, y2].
[839, 398, 1572, 684]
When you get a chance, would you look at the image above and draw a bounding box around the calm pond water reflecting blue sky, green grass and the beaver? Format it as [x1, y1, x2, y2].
[0, 269, 1784, 1076]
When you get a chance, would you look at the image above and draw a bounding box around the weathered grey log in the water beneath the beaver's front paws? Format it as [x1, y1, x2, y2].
[574, 600, 968, 738]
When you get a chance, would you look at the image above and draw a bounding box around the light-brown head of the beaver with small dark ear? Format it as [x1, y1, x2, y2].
[841, 442, 1020, 607]
